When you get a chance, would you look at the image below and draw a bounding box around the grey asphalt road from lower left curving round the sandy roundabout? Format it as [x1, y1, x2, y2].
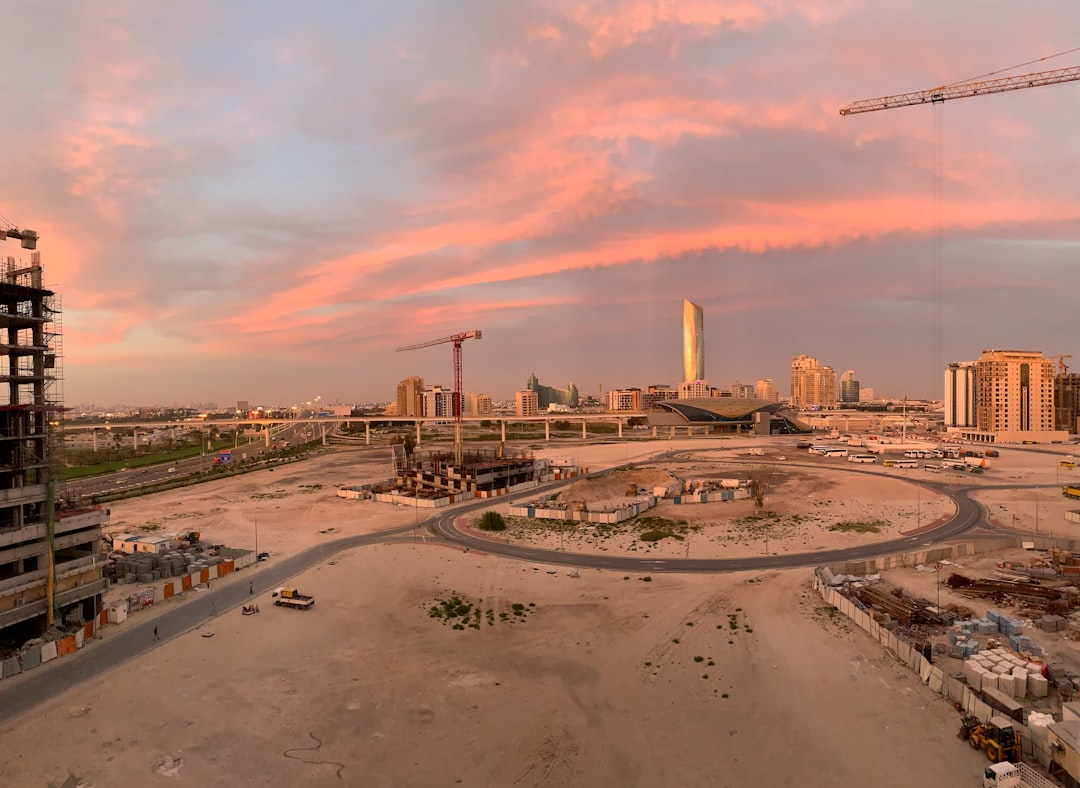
[0, 456, 983, 723]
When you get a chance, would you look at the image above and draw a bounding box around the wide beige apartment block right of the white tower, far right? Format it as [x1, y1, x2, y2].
[958, 350, 1068, 443]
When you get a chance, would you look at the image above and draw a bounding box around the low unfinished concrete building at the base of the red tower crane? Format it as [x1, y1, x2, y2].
[393, 444, 546, 498]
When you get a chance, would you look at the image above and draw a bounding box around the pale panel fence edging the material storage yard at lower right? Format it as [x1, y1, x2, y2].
[813, 559, 1056, 772]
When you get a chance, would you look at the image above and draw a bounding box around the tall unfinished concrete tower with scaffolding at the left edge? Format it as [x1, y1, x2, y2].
[0, 250, 108, 653]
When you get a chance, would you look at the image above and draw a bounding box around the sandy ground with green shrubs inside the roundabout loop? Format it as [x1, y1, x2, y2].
[494, 447, 956, 558]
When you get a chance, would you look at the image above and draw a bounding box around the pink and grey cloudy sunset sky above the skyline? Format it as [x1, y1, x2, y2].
[0, 0, 1080, 405]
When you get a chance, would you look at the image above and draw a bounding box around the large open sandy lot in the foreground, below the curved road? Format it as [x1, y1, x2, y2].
[0, 544, 983, 788]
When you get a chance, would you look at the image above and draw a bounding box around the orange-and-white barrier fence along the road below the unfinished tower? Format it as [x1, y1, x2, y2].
[0, 551, 257, 680]
